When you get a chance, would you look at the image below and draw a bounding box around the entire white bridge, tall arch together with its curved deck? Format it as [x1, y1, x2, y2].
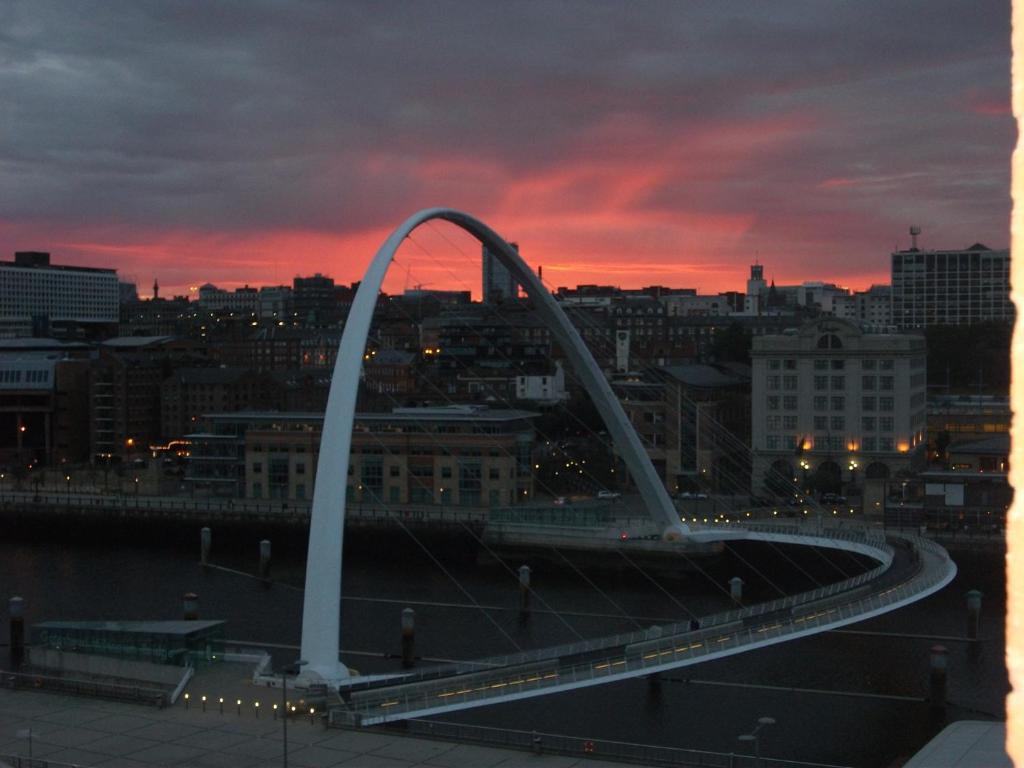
[300, 208, 956, 725]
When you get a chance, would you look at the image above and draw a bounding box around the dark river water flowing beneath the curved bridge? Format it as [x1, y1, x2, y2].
[0, 526, 1009, 766]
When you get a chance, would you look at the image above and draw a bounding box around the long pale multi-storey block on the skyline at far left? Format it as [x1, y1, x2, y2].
[0, 251, 121, 337]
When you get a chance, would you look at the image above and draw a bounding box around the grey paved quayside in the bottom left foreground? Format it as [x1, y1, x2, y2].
[0, 689, 621, 768]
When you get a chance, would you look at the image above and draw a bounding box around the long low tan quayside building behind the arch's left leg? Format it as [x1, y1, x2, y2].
[186, 406, 537, 507]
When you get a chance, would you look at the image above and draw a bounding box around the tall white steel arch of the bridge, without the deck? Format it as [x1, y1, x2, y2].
[301, 208, 689, 683]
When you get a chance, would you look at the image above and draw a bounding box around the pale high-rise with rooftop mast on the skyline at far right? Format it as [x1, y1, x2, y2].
[892, 237, 1014, 329]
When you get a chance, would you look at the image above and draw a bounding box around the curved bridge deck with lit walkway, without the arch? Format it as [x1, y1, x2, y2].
[331, 525, 956, 725]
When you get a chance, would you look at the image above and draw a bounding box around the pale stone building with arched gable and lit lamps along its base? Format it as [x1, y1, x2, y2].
[751, 319, 927, 494]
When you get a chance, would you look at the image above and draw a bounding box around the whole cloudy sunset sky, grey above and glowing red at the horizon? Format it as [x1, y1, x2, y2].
[0, 0, 1014, 294]
